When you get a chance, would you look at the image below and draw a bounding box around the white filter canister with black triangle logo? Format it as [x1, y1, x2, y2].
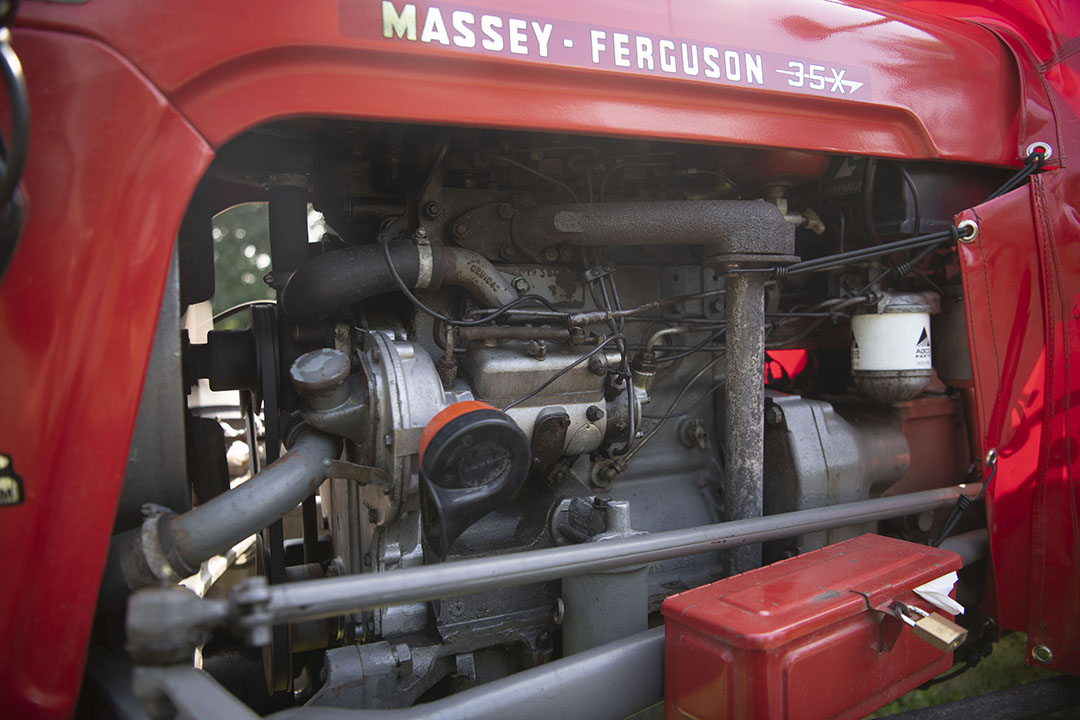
[851, 293, 941, 403]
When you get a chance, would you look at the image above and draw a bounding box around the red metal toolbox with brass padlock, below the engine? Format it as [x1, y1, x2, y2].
[662, 534, 961, 720]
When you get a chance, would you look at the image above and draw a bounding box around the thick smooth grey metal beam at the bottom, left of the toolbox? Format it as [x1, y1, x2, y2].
[270, 627, 664, 720]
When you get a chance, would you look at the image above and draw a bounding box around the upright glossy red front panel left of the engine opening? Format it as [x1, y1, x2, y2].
[0, 30, 211, 718]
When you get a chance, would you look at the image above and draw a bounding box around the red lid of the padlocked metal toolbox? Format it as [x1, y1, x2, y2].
[661, 534, 962, 650]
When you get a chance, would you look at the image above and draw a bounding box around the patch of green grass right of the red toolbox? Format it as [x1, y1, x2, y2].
[867, 633, 1080, 720]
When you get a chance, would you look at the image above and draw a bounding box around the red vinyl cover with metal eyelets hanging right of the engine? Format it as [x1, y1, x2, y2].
[959, 171, 1080, 673]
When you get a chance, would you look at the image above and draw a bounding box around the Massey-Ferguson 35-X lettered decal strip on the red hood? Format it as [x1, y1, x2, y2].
[371, 0, 869, 100]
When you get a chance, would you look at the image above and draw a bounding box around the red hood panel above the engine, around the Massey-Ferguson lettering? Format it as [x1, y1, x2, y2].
[22, 0, 1018, 164]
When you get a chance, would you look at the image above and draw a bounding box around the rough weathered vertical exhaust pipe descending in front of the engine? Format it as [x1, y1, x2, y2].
[725, 272, 765, 573]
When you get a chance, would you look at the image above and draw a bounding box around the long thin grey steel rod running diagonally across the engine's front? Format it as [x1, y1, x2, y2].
[247, 485, 982, 624]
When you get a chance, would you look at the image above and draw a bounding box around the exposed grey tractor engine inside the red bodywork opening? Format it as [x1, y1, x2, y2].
[107, 120, 1001, 708]
